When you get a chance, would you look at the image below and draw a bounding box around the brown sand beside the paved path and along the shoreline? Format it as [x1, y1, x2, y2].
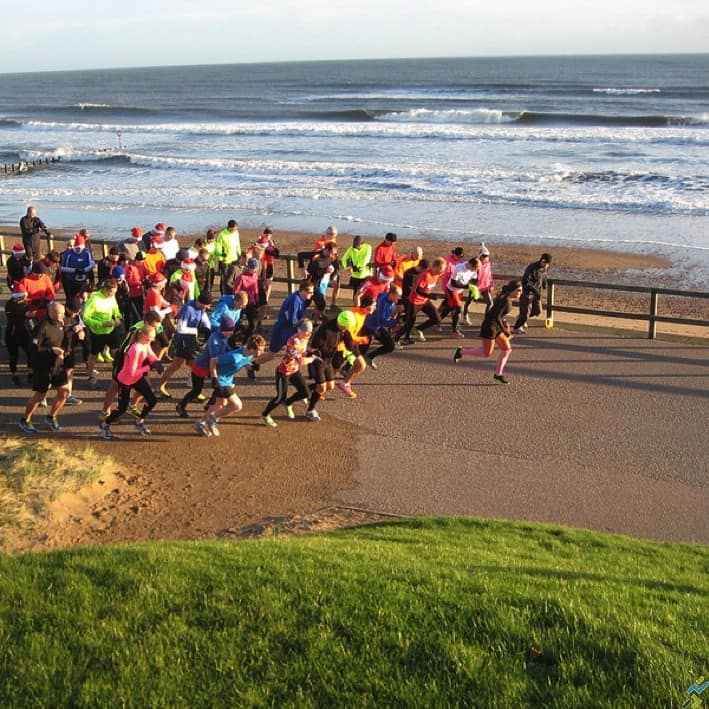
[0, 224, 709, 550]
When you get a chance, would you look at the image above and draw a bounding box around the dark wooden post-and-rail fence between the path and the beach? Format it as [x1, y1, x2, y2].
[0, 234, 709, 340]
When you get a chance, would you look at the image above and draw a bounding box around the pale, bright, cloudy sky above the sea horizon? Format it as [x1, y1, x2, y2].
[0, 0, 709, 73]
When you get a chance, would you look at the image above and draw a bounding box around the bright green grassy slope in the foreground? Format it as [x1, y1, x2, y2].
[0, 519, 709, 707]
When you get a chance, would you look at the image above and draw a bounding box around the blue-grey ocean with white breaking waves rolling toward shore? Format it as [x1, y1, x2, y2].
[0, 55, 709, 289]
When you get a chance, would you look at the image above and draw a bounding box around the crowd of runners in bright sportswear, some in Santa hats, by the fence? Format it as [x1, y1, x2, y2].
[5, 207, 551, 439]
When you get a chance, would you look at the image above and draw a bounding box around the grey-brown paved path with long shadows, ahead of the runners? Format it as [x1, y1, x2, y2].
[0, 323, 709, 543]
